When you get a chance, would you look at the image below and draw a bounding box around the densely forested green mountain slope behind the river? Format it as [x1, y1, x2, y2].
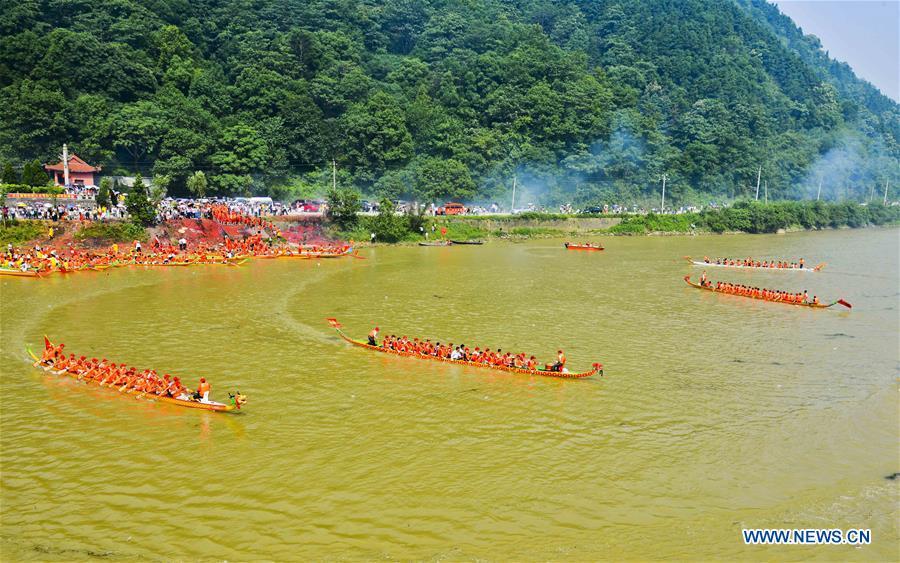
[0, 0, 900, 203]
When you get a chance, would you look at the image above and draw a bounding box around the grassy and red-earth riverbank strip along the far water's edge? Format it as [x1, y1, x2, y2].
[0, 202, 900, 248]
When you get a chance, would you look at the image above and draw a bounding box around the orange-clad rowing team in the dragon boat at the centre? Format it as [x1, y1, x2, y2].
[369, 327, 566, 372]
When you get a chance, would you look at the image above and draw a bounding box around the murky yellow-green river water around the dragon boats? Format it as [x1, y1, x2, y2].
[0, 229, 900, 561]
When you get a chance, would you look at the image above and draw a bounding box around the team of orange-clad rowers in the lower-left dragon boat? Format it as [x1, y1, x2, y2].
[40, 342, 212, 403]
